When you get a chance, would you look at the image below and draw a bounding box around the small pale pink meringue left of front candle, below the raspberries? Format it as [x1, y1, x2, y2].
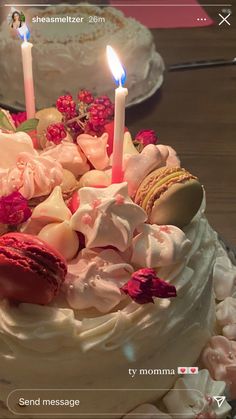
[77, 133, 109, 170]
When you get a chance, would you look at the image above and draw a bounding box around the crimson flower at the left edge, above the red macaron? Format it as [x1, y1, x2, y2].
[0, 192, 31, 225]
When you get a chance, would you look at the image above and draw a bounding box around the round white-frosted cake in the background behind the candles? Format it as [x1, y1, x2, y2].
[0, 4, 164, 109]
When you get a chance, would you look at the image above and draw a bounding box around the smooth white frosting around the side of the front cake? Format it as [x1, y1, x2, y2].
[0, 208, 221, 418]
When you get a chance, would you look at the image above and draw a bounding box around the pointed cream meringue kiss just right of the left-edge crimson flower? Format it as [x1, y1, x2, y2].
[32, 186, 72, 225]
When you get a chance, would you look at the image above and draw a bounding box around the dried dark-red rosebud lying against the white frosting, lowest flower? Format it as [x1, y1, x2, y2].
[121, 268, 177, 304]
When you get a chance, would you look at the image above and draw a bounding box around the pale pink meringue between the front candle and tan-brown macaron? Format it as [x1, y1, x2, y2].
[124, 144, 166, 196]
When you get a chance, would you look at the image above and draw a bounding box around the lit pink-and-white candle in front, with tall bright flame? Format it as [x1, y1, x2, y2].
[107, 46, 128, 183]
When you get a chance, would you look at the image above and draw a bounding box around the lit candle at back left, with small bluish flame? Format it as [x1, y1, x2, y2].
[18, 24, 35, 119]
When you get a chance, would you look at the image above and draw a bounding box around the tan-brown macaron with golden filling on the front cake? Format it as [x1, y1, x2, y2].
[135, 167, 203, 228]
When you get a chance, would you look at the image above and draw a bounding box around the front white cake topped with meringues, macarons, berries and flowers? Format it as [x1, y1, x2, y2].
[0, 91, 236, 419]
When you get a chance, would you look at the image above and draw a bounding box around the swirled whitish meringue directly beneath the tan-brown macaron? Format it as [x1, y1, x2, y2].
[131, 226, 191, 268]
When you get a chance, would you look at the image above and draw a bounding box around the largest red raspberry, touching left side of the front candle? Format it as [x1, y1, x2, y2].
[88, 96, 114, 132]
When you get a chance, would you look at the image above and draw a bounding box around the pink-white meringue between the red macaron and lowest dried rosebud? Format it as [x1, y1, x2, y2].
[64, 249, 133, 313]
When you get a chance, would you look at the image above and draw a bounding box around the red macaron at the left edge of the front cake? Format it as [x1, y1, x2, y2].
[0, 233, 67, 304]
